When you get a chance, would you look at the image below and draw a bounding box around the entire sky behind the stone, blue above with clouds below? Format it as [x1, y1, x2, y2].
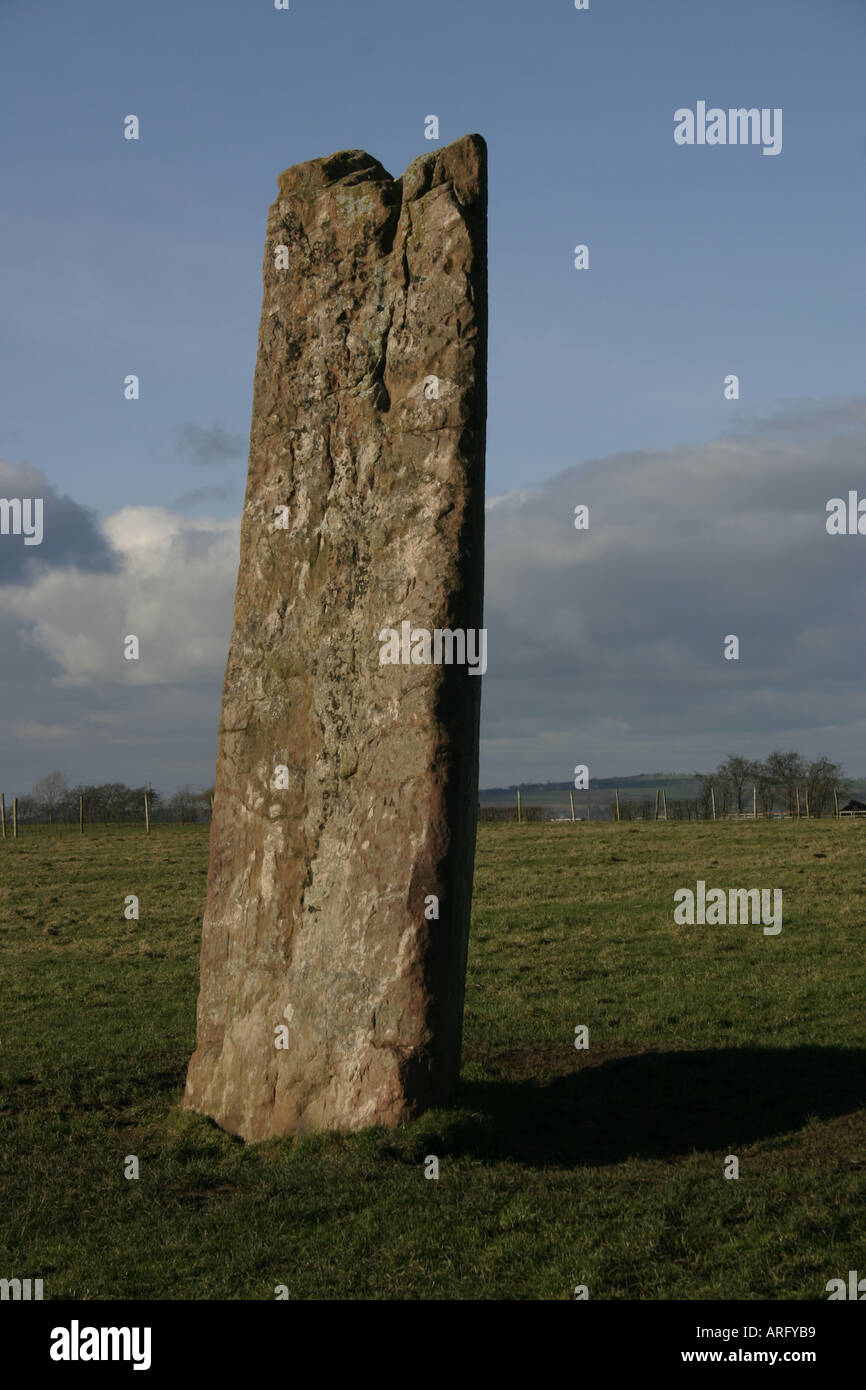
[0, 0, 866, 798]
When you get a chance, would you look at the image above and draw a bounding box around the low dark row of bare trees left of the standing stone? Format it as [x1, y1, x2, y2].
[7, 771, 214, 824]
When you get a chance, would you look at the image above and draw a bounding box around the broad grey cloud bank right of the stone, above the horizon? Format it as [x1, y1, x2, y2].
[482, 400, 866, 785]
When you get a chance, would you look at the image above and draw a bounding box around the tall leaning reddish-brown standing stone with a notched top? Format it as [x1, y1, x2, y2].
[185, 135, 487, 1140]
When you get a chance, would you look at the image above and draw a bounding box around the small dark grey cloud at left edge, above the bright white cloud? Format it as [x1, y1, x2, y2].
[0, 460, 118, 584]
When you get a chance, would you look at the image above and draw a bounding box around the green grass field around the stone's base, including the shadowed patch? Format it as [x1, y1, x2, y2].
[0, 820, 866, 1300]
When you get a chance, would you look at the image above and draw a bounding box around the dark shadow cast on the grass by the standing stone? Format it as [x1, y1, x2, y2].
[453, 1047, 866, 1166]
